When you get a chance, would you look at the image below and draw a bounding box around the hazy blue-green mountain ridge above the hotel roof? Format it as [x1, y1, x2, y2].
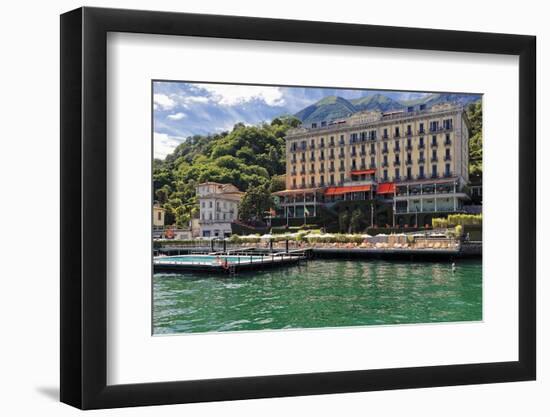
[294, 93, 480, 126]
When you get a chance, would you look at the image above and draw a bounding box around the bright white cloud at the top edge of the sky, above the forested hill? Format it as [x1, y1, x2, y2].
[200, 84, 285, 106]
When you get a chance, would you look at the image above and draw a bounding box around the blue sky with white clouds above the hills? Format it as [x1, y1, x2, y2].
[153, 81, 427, 158]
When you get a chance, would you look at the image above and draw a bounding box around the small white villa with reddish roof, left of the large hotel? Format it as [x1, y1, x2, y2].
[196, 182, 244, 237]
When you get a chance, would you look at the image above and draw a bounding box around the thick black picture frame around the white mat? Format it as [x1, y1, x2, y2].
[60, 7, 536, 409]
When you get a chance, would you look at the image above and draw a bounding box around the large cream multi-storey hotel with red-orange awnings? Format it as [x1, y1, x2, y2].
[275, 103, 469, 225]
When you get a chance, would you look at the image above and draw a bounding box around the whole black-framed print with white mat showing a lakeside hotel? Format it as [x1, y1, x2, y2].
[61, 8, 536, 409]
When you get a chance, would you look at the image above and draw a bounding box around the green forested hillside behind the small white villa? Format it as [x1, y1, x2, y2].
[153, 117, 299, 227]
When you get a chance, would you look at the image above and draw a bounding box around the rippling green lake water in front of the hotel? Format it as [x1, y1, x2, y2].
[153, 259, 482, 334]
